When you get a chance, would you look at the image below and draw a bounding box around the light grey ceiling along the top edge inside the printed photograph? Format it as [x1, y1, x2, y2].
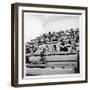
[24, 13, 78, 23]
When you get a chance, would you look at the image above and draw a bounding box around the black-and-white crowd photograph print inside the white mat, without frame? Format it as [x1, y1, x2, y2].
[24, 12, 80, 76]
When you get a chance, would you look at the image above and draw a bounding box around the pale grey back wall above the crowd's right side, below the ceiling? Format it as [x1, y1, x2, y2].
[46, 17, 79, 32]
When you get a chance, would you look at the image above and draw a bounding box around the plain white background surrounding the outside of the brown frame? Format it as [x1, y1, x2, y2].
[0, 0, 90, 90]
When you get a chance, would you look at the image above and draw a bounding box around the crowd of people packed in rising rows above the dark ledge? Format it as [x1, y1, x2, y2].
[26, 28, 79, 54]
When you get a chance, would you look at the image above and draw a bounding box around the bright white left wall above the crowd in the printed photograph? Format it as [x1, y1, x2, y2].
[24, 13, 44, 42]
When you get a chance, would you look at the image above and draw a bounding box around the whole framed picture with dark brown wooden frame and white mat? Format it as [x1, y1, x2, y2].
[11, 3, 87, 86]
